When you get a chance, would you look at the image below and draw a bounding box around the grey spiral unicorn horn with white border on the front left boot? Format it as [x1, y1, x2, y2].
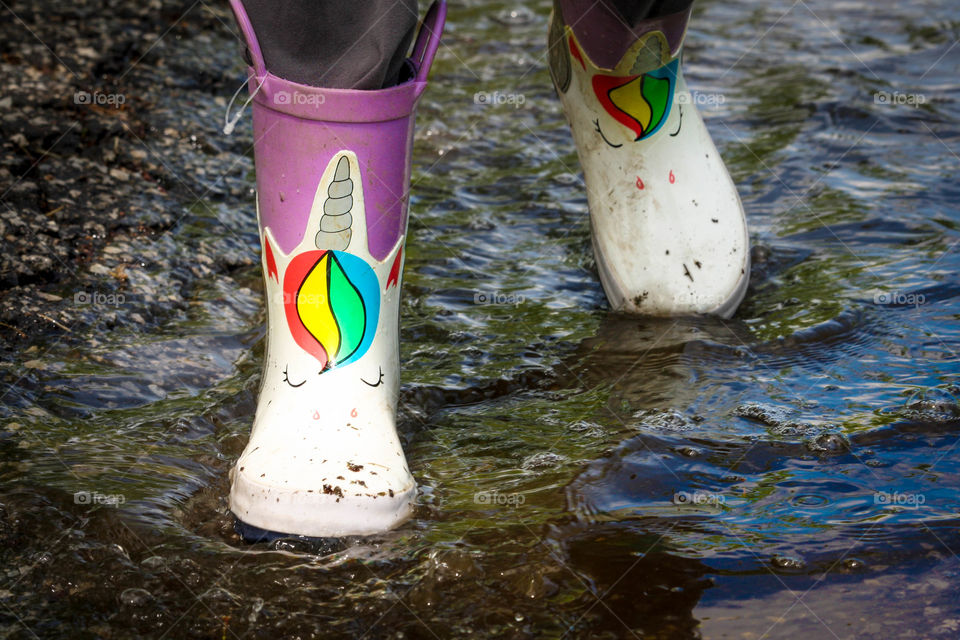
[307, 150, 367, 254]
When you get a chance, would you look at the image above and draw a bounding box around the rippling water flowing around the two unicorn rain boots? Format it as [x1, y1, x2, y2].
[0, 0, 960, 638]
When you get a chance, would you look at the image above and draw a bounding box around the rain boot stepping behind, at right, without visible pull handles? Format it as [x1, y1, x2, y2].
[549, 0, 750, 317]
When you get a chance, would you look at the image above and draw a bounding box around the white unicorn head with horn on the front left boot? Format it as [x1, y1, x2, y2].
[230, 151, 416, 537]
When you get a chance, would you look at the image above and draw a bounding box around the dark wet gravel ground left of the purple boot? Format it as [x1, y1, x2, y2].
[0, 0, 257, 350]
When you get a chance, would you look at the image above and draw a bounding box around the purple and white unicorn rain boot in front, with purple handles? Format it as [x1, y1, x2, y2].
[230, 0, 446, 537]
